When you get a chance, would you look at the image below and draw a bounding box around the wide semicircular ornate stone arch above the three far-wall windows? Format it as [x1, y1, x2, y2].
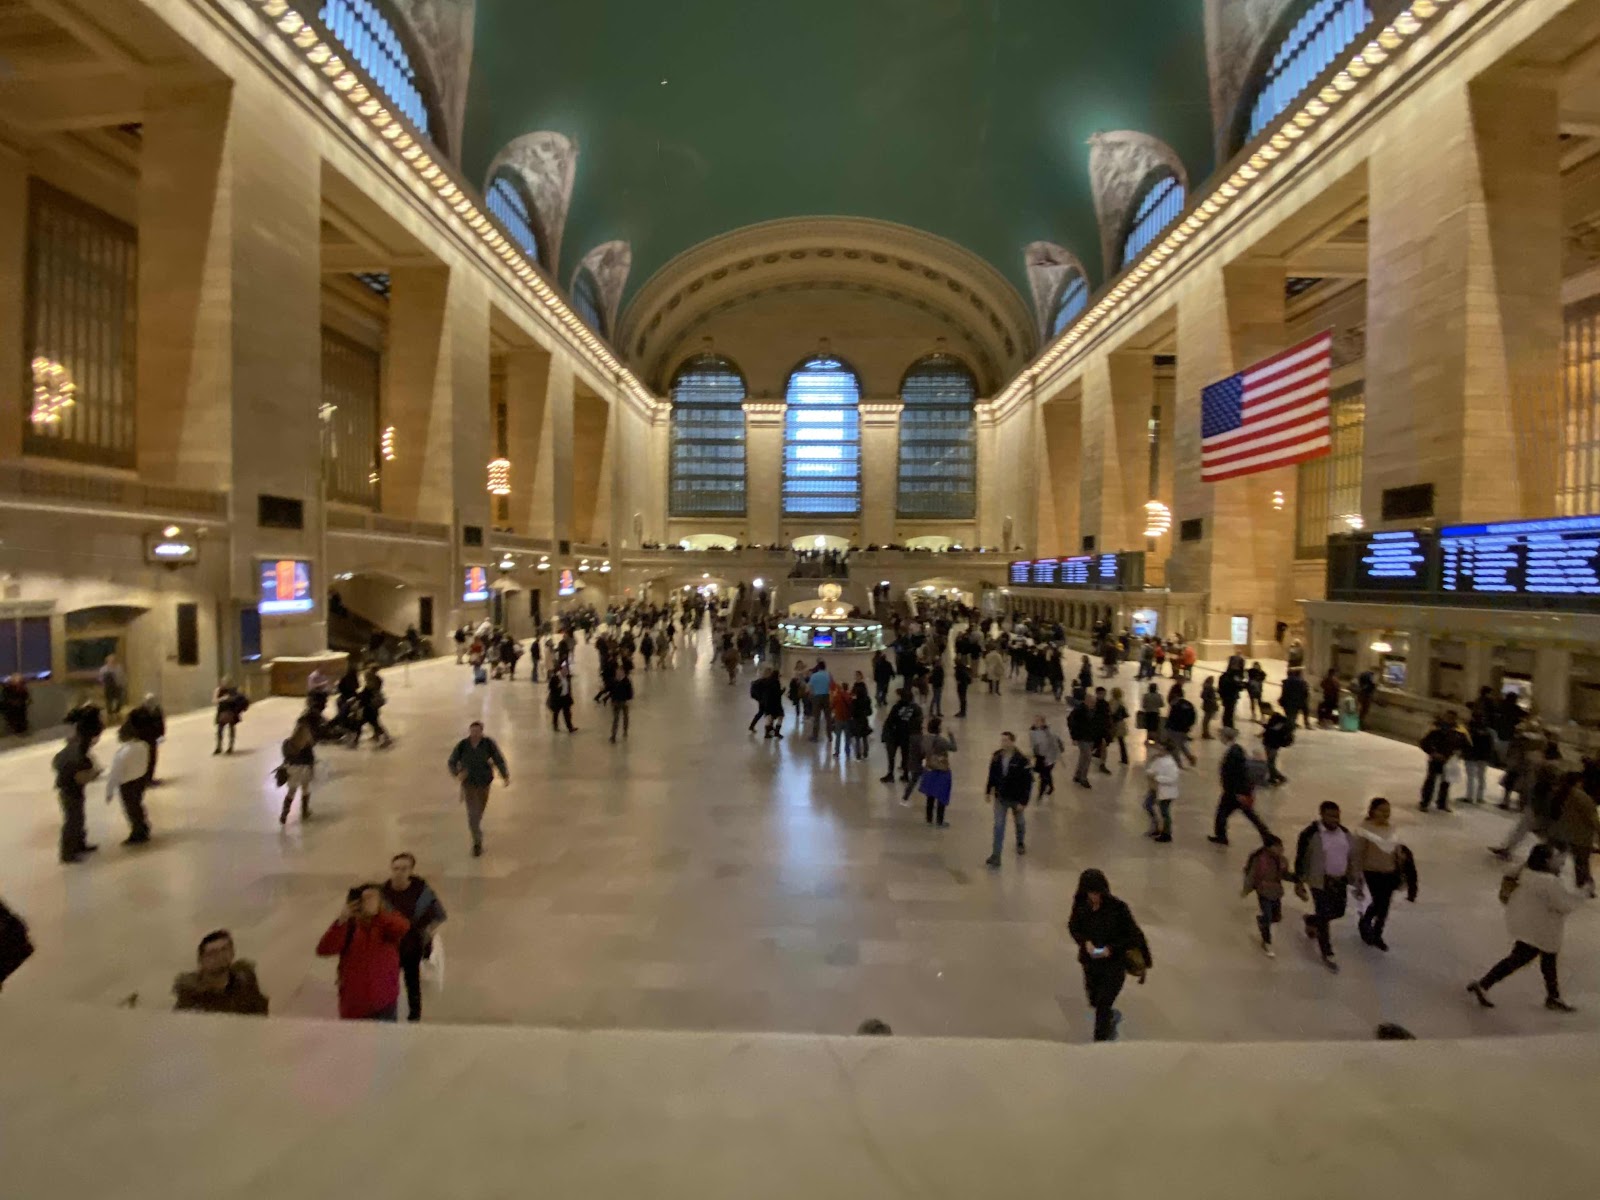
[616, 218, 1038, 394]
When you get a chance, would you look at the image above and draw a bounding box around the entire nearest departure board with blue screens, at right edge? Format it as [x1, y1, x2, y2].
[1328, 517, 1600, 611]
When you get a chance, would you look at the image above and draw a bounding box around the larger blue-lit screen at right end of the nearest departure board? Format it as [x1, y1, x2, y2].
[1438, 517, 1600, 602]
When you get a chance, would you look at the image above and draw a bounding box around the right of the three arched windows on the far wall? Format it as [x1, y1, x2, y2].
[894, 354, 978, 520]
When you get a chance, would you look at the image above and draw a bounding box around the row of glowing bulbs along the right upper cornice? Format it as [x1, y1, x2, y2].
[990, 0, 1456, 411]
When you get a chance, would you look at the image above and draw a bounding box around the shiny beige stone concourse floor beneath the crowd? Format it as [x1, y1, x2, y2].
[0, 633, 1600, 1042]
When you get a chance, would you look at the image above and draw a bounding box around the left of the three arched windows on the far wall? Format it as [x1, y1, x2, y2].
[669, 354, 746, 517]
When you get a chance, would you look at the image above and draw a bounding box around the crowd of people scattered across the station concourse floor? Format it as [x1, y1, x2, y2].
[0, 594, 1600, 1040]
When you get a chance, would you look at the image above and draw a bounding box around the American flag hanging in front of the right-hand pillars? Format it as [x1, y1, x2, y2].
[1200, 333, 1333, 483]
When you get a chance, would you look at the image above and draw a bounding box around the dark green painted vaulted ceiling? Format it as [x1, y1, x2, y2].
[464, 0, 1213, 310]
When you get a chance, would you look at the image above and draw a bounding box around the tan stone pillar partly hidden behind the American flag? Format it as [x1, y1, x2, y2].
[1166, 264, 1296, 658]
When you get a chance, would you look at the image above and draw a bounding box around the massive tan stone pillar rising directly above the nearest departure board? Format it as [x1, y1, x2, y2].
[1362, 67, 1563, 523]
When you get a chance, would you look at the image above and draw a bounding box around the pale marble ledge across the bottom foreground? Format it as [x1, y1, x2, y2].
[0, 998, 1600, 1200]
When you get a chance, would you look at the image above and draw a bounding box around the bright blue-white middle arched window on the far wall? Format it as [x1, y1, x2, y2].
[784, 354, 861, 517]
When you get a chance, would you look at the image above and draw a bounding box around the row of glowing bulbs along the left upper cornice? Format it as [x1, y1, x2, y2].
[238, 0, 664, 411]
